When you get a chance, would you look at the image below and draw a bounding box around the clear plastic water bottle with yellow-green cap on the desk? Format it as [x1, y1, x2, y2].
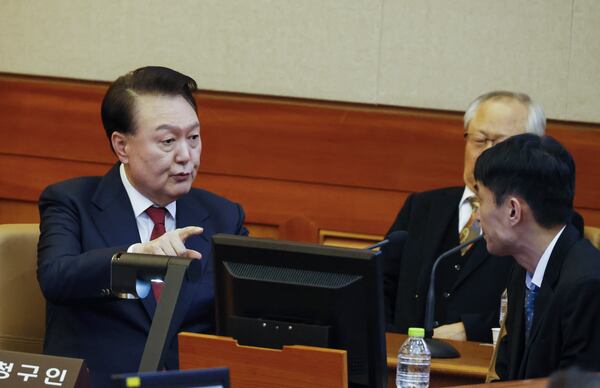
[396, 327, 431, 388]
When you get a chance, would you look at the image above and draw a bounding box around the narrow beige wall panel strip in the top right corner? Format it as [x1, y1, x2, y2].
[567, 0, 600, 122]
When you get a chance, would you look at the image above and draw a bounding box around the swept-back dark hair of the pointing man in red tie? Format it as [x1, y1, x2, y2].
[102, 66, 197, 146]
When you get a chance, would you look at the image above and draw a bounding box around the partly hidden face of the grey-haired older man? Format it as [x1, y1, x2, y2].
[463, 99, 528, 190]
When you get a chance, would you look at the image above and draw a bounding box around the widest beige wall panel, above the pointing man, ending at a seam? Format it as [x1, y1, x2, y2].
[0, 0, 381, 102]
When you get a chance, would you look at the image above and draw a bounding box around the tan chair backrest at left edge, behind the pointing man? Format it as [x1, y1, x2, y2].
[0, 224, 46, 353]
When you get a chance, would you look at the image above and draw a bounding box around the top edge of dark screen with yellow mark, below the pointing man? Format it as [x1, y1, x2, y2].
[112, 368, 229, 388]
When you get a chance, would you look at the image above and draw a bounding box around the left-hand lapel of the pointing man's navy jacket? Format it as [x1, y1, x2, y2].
[92, 163, 156, 320]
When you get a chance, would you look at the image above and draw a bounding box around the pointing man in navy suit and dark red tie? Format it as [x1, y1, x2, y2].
[38, 67, 245, 387]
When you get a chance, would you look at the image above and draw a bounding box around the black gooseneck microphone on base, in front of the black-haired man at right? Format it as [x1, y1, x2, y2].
[424, 235, 483, 358]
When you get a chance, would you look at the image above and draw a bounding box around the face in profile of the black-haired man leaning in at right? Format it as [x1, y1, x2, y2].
[475, 182, 513, 256]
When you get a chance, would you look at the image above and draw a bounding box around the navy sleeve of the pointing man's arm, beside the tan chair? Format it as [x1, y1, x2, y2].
[37, 186, 127, 303]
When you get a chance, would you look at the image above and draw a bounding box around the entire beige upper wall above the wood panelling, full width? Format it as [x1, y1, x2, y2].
[0, 0, 600, 122]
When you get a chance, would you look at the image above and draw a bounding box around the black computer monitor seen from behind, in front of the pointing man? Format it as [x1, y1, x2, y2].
[213, 234, 387, 388]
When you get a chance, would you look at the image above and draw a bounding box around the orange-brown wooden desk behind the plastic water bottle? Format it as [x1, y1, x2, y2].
[385, 333, 493, 387]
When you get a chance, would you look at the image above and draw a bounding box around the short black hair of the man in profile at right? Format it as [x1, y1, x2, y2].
[475, 134, 575, 228]
